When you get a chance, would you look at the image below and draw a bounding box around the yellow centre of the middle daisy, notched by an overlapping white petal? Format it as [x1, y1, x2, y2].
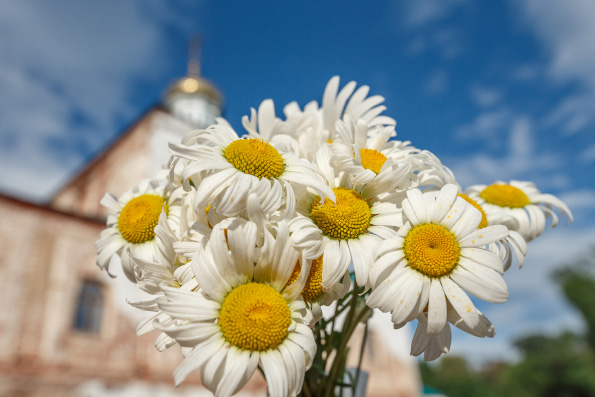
[310, 187, 372, 240]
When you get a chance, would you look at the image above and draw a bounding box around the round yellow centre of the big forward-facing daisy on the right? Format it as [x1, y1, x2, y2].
[404, 223, 460, 277]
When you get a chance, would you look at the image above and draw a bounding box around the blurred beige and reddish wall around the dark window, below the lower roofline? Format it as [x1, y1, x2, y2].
[0, 198, 263, 396]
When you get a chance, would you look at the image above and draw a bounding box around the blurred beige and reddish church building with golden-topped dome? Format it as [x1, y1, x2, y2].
[0, 62, 421, 397]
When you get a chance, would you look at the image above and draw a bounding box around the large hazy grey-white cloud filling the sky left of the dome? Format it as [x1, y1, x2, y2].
[0, 0, 203, 201]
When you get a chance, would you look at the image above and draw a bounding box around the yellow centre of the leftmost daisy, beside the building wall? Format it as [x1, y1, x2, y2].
[118, 194, 168, 244]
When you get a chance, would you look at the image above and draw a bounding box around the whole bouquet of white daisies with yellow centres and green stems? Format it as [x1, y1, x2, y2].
[96, 77, 572, 397]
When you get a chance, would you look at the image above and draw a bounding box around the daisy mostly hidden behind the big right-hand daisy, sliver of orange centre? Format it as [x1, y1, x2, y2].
[458, 193, 527, 271]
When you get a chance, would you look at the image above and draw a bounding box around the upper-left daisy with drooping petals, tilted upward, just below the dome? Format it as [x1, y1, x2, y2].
[170, 125, 334, 216]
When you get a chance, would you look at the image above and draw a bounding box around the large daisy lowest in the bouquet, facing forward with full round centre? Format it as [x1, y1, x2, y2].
[155, 222, 316, 397]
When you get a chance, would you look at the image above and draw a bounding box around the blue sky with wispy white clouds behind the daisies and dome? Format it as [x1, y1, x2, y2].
[0, 0, 595, 366]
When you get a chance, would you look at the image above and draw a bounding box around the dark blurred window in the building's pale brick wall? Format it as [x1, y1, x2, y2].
[73, 281, 103, 333]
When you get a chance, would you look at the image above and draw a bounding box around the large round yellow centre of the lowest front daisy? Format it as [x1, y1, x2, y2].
[219, 283, 291, 351]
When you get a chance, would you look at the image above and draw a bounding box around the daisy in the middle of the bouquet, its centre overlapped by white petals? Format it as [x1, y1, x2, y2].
[290, 145, 402, 289]
